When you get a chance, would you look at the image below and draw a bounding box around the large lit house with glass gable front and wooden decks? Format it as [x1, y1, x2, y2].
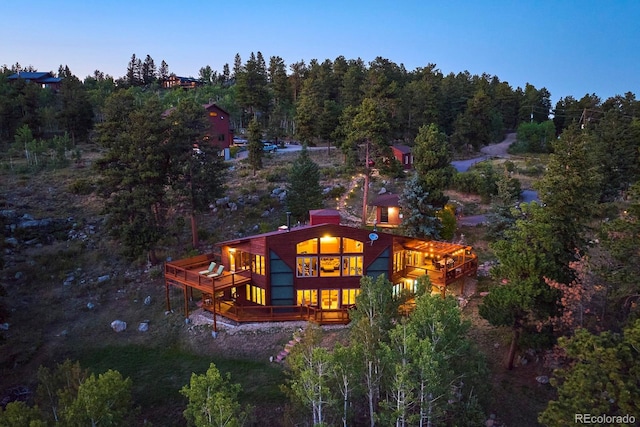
[165, 210, 478, 327]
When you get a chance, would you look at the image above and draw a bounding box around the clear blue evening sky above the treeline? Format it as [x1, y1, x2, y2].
[0, 0, 640, 102]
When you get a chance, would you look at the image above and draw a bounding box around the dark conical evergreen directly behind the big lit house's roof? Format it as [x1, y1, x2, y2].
[286, 145, 322, 222]
